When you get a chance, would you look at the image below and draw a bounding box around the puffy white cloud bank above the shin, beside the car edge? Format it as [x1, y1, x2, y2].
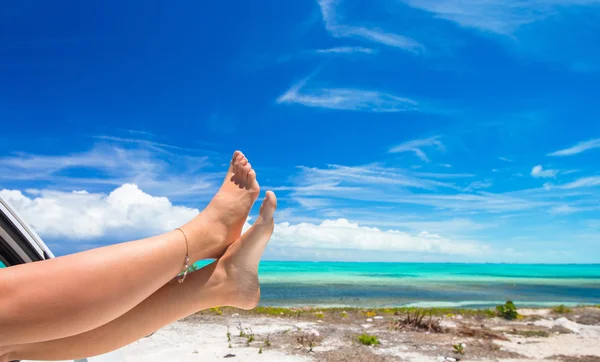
[0, 184, 199, 241]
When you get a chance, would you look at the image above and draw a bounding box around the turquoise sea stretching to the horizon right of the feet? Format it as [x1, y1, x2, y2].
[240, 261, 600, 308]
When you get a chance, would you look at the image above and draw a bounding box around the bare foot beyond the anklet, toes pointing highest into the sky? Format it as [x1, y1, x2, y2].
[182, 151, 260, 261]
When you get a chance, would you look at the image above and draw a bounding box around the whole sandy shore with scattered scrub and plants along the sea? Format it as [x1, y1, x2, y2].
[121, 306, 600, 362]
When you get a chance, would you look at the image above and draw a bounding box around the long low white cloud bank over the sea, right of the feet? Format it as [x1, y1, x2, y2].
[271, 219, 489, 256]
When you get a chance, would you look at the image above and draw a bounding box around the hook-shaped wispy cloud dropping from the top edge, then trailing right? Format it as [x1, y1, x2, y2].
[318, 0, 424, 53]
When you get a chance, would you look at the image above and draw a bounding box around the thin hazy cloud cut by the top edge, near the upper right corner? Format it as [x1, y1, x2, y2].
[403, 0, 599, 35]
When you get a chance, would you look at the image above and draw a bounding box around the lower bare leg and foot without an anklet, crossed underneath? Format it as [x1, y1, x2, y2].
[0, 192, 276, 361]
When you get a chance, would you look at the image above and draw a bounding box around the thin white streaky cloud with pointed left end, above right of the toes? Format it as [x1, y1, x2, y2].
[277, 77, 417, 112]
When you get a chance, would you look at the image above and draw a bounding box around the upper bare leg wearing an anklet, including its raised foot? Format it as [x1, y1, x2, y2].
[0, 152, 259, 346]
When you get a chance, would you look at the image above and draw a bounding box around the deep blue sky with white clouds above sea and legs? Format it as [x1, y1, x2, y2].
[0, 0, 600, 263]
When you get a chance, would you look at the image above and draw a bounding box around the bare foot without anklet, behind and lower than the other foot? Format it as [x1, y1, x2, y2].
[213, 191, 277, 309]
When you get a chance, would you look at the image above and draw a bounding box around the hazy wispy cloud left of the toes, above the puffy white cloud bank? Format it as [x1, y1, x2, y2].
[0, 137, 225, 199]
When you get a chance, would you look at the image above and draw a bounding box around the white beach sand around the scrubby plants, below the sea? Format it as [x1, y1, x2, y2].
[22, 308, 600, 362]
